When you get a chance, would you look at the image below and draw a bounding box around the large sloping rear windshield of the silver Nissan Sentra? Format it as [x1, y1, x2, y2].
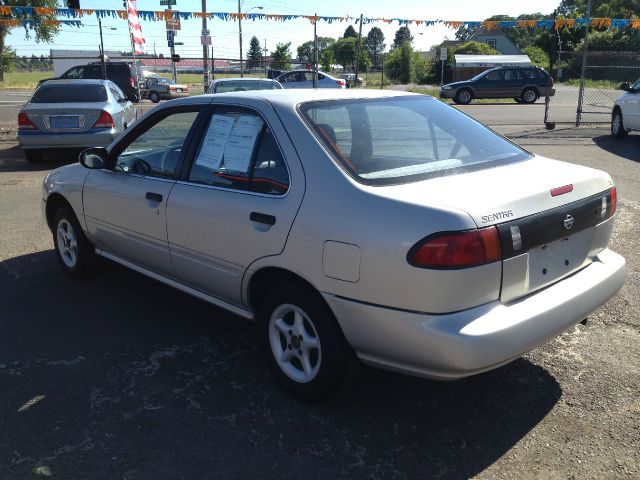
[300, 96, 531, 185]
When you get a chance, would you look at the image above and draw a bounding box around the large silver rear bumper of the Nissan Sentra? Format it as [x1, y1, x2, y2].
[323, 250, 626, 380]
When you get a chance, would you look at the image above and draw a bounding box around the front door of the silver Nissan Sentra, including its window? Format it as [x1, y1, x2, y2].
[83, 106, 201, 276]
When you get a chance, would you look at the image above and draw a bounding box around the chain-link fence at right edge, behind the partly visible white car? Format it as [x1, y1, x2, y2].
[544, 51, 640, 128]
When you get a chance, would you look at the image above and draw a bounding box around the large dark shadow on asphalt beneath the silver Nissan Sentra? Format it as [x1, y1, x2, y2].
[0, 251, 561, 479]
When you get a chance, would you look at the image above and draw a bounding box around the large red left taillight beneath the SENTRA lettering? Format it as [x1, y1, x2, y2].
[407, 227, 502, 269]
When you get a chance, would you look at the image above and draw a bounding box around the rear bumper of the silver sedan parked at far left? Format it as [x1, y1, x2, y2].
[18, 129, 119, 149]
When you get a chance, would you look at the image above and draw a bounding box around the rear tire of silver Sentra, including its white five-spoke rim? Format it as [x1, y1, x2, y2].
[259, 283, 358, 403]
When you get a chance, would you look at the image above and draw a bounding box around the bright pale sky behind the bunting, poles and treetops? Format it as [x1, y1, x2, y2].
[8, 0, 559, 58]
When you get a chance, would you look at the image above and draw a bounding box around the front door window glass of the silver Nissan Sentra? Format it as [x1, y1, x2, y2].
[114, 111, 198, 178]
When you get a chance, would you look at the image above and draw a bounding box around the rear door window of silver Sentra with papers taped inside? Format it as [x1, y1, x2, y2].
[189, 112, 289, 195]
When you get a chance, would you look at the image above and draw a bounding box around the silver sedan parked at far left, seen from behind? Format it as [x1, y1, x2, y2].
[18, 80, 137, 162]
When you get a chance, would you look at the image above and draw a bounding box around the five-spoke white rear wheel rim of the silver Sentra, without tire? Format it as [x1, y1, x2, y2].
[269, 303, 322, 383]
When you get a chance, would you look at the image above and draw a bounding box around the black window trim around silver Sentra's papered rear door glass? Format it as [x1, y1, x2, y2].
[178, 103, 292, 198]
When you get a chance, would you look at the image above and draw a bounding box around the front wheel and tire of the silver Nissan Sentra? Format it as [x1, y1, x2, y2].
[53, 207, 97, 278]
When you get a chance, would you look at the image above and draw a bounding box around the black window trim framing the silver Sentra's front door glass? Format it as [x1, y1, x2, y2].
[107, 103, 207, 182]
